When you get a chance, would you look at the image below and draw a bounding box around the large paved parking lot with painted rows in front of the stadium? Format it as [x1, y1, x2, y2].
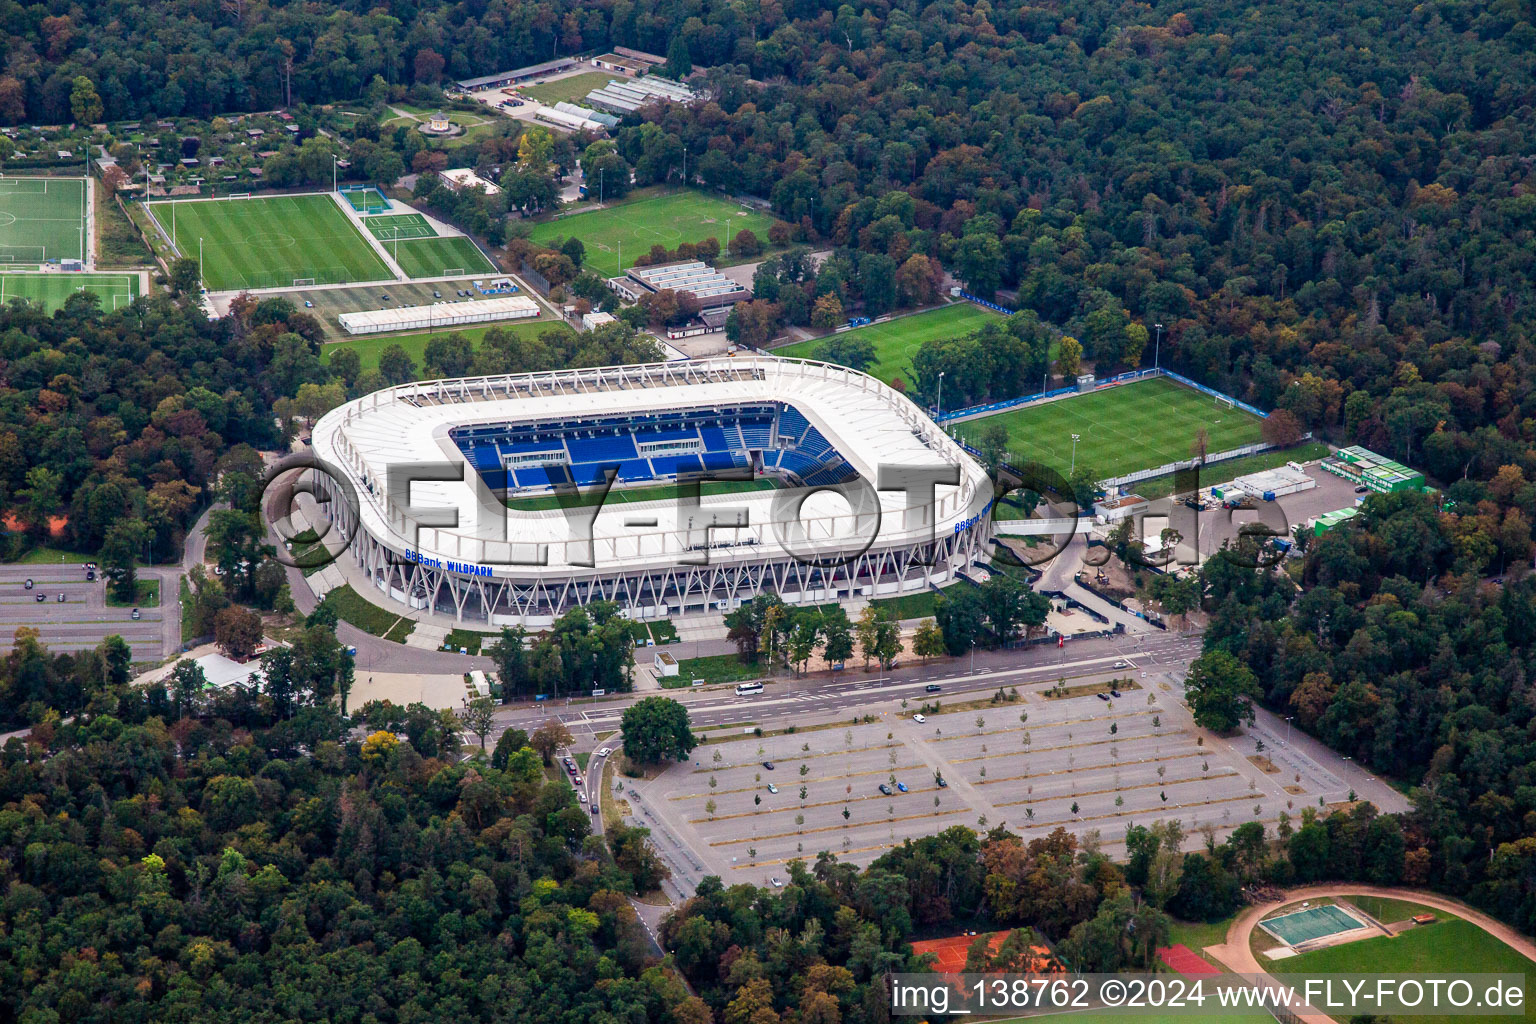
[647, 682, 1296, 883]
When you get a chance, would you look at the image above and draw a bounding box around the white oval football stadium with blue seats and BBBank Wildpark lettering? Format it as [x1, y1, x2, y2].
[312, 358, 991, 626]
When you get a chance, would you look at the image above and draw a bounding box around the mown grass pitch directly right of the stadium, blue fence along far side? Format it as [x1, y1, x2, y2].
[951, 378, 1264, 477]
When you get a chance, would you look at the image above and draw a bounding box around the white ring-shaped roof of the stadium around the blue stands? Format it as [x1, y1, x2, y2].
[313, 356, 991, 577]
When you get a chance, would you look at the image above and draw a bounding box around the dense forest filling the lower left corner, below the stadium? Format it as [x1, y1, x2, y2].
[0, 635, 706, 1024]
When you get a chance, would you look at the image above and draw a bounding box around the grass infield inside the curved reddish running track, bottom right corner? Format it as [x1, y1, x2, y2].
[1270, 914, 1536, 1024]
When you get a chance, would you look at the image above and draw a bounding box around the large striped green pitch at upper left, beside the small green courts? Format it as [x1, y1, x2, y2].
[149, 195, 395, 292]
